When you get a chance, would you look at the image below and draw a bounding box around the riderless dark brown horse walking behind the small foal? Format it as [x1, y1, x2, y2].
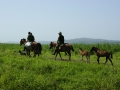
[90, 47, 113, 65]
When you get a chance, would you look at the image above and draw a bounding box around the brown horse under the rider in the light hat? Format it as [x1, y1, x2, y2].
[50, 42, 74, 60]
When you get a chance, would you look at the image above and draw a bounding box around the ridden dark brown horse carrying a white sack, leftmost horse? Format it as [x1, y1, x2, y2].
[20, 38, 42, 56]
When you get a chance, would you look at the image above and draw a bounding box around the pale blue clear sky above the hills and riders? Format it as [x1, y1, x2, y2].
[0, 0, 120, 42]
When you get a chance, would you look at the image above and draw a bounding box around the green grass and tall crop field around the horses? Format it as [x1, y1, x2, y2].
[0, 43, 120, 90]
